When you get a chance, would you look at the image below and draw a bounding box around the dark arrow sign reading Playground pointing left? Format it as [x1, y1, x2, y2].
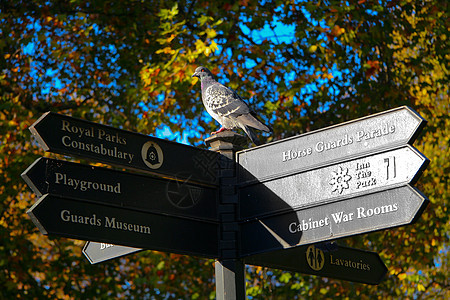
[22, 158, 219, 221]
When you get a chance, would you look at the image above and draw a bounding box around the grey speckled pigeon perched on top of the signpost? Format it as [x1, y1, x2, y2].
[192, 67, 272, 146]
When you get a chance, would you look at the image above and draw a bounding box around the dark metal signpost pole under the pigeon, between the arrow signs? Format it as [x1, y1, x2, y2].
[205, 131, 247, 300]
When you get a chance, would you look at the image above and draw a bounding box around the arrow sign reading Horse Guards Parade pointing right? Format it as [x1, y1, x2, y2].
[237, 107, 426, 183]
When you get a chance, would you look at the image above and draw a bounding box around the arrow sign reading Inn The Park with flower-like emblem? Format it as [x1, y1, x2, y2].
[239, 145, 429, 219]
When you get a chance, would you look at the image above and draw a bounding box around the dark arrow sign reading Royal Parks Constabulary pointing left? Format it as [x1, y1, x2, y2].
[30, 112, 218, 185]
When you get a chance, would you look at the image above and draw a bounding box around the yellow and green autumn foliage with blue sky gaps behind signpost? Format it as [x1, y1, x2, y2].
[0, 0, 450, 299]
